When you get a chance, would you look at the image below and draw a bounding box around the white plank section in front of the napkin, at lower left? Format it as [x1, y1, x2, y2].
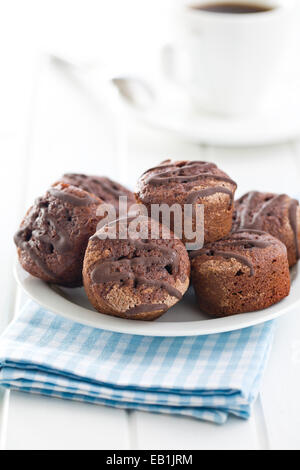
[6, 392, 129, 450]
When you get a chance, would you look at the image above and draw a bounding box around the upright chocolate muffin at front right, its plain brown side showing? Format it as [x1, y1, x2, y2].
[190, 230, 290, 316]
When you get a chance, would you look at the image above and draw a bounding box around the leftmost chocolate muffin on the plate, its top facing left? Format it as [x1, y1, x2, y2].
[14, 183, 102, 287]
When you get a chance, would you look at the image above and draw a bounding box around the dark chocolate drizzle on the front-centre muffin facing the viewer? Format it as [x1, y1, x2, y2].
[91, 238, 182, 311]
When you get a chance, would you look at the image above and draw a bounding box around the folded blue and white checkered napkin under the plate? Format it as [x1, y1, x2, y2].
[0, 302, 273, 423]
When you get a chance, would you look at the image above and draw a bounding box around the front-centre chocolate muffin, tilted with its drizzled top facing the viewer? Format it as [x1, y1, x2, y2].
[83, 217, 190, 320]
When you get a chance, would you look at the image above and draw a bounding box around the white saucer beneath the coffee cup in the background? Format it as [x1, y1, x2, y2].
[125, 74, 300, 146]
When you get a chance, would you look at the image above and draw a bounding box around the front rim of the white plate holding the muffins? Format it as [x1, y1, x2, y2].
[13, 261, 300, 337]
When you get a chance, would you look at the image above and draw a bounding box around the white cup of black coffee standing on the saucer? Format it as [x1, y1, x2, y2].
[164, 0, 294, 115]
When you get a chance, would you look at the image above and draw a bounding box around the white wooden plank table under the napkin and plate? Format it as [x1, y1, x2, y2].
[0, 49, 300, 450]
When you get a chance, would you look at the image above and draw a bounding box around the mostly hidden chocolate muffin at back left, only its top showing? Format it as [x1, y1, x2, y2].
[62, 173, 136, 213]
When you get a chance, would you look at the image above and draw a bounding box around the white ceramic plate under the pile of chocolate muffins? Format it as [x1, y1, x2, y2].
[15, 263, 300, 336]
